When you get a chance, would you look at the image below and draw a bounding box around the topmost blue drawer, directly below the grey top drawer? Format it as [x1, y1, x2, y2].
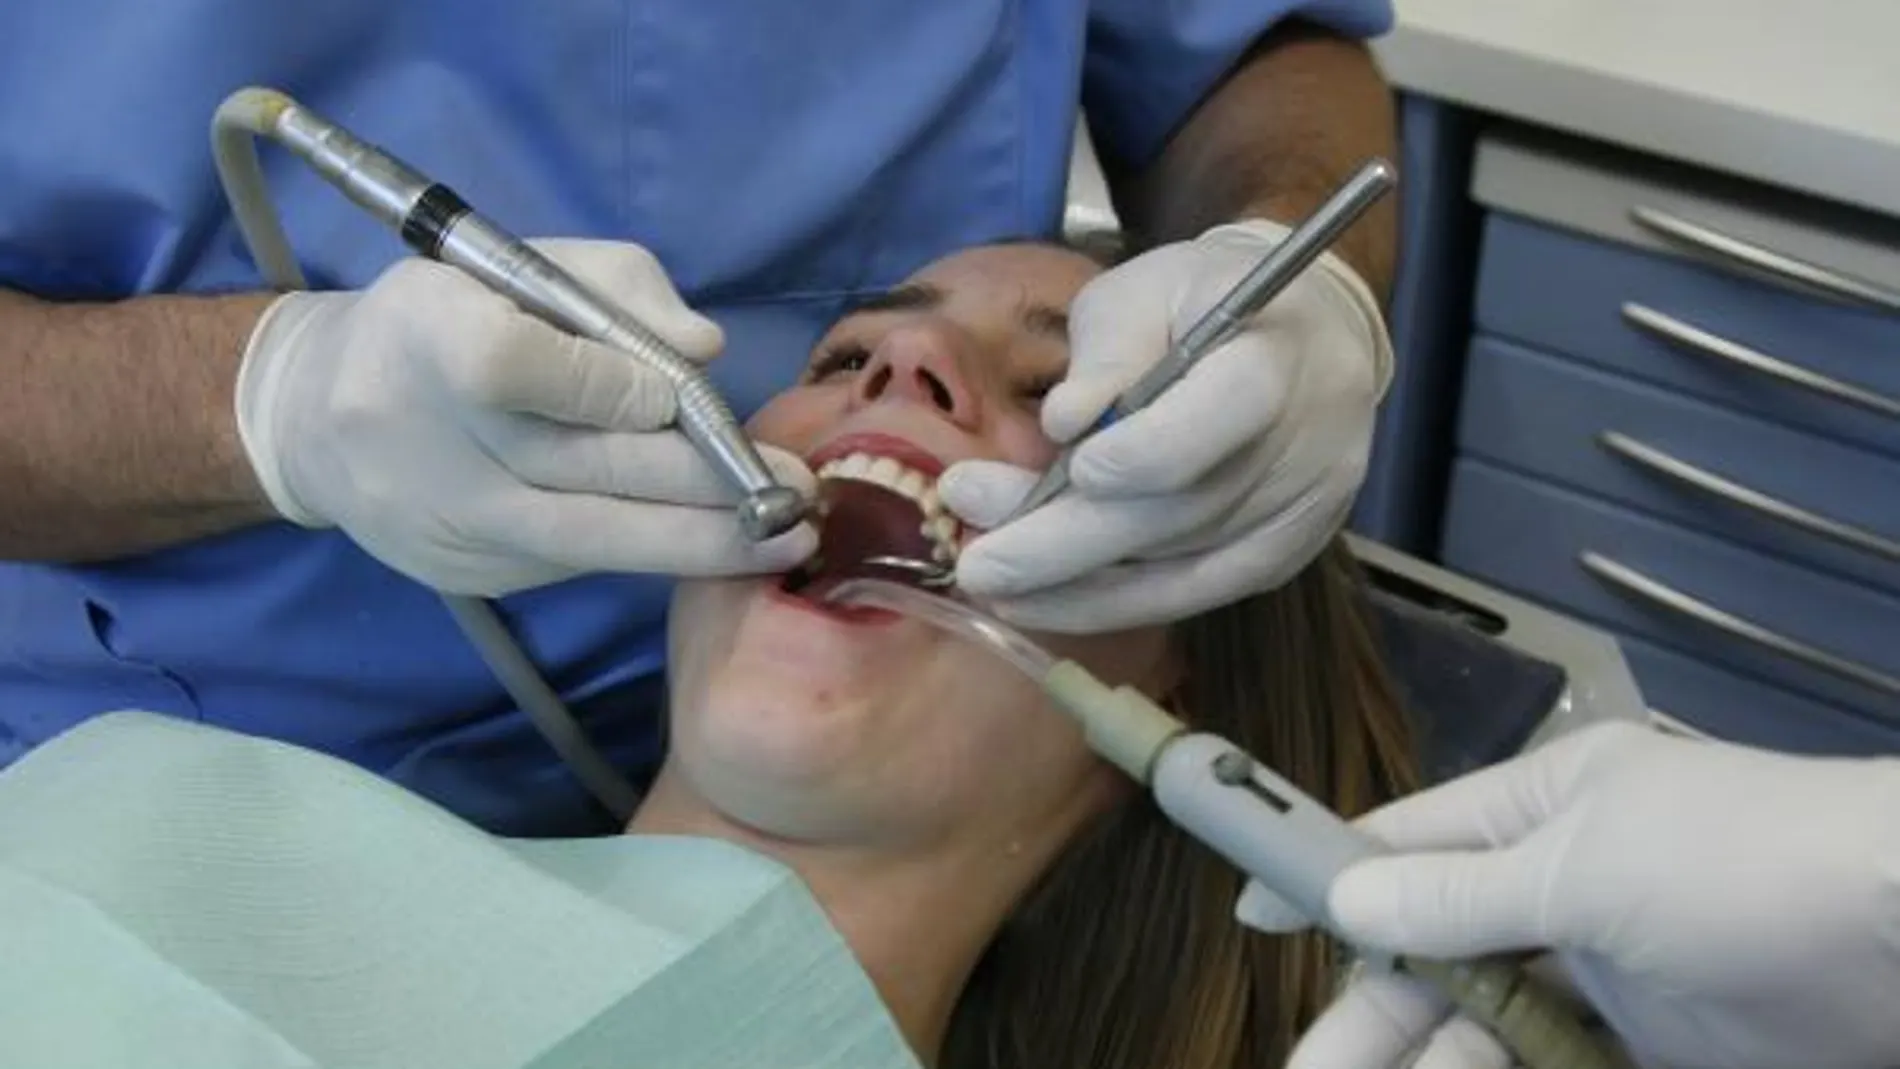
[1476, 213, 1900, 456]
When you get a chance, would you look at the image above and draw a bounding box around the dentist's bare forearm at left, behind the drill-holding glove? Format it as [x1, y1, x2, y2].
[0, 291, 272, 562]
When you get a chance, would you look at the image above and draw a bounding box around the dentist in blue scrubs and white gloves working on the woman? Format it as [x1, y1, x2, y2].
[0, 0, 1395, 835]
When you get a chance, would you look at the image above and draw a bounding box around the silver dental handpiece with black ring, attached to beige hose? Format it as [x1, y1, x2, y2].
[213, 87, 809, 541]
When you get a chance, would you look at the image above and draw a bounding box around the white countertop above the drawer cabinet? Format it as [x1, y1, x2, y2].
[1374, 0, 1900, 216]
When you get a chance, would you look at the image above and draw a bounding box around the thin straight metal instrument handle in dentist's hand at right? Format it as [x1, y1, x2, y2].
[1005, 159, 1398, 522]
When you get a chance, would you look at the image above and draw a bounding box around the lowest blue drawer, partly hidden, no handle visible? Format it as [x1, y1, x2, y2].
[1613, 634, 1900, 756]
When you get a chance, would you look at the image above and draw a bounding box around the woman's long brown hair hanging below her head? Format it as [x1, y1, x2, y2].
[941, 543, 1416, 1069]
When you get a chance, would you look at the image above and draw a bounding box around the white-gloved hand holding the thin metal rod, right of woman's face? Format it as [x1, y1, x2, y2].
[939, 220, 1393, 632]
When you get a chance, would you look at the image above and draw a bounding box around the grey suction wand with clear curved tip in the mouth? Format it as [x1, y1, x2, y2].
[827, 579, 1630, 1069]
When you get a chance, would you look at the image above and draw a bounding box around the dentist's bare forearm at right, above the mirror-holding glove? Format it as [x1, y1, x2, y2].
[1104, 21, 1398, 302]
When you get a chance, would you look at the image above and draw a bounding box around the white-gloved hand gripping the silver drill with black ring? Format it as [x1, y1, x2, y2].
[238, 241, 817, 596]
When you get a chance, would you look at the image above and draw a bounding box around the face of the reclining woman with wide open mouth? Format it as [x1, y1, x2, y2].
[669, 245, 1167, 851]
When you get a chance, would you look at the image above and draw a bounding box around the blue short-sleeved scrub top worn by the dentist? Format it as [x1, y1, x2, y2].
[0, 0, 1391, 835]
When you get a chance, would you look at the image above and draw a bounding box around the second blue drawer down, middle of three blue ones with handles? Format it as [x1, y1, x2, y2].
[1457, 336, 1900, 591]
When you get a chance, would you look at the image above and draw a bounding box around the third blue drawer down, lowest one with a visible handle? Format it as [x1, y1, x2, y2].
[1442, 458, 1900, 722]
